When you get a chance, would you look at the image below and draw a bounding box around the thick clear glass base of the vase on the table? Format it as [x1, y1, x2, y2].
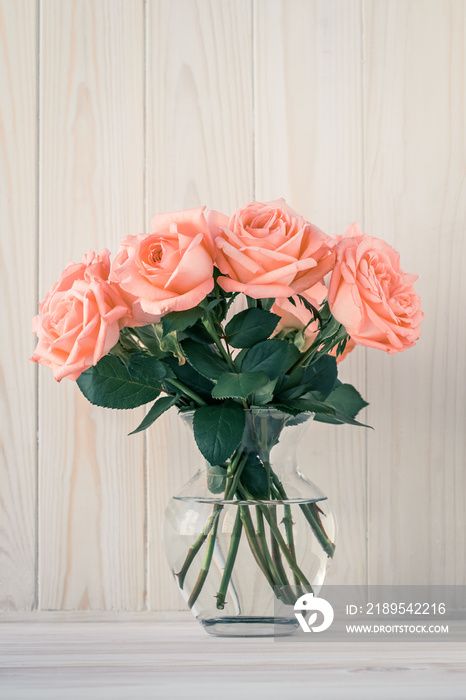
[200, 615, 299, 637]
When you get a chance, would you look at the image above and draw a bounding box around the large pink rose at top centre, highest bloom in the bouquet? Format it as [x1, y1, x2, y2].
[207, 199, 335, 299]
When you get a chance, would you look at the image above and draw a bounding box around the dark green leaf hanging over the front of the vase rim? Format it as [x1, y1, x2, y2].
[193, 400, 245, 466]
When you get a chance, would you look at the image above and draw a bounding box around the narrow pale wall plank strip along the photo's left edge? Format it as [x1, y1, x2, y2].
[0, 0, 37, 610]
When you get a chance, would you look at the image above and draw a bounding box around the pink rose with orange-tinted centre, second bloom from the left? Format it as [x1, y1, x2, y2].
[110, 207, 214, 318]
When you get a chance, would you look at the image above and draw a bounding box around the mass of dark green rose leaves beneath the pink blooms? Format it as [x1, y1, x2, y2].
[77, 274, 367, 492]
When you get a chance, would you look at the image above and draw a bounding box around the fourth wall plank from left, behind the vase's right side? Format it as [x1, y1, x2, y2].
[254, 0, 366, 584]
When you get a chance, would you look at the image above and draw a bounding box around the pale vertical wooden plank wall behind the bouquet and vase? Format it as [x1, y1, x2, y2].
[0, 0, 466, 619]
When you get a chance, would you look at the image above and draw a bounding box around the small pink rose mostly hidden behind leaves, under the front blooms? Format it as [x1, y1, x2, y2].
[271, 282, 327, 352]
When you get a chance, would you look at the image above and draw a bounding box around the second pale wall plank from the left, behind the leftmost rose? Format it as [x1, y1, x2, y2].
[39, 0, 145, 610]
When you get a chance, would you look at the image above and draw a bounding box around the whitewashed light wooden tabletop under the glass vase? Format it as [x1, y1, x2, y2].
[0, 620, 466, 700]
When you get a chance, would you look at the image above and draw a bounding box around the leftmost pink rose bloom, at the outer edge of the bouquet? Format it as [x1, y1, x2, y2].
[31, 249, 137, 381]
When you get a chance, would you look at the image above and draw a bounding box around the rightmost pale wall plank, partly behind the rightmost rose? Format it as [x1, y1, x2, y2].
[364, 0, 466, 584]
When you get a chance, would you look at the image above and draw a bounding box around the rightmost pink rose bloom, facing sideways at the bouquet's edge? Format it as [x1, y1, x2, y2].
[328, 224, 424, 353]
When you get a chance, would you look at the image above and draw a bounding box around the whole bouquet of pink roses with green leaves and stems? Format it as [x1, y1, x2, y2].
[32, 200, 423, 608]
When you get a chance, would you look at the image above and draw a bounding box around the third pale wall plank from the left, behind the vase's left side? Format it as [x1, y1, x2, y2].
[146, 0, 253, 609]
